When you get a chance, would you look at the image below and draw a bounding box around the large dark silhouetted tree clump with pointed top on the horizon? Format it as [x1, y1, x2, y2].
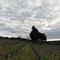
[30, 26, 47, 42]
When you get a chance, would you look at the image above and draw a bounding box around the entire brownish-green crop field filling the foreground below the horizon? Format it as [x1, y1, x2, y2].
[0, 40, 60, 60]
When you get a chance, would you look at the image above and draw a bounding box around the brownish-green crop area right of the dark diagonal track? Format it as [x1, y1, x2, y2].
[39, 45, 60, 60]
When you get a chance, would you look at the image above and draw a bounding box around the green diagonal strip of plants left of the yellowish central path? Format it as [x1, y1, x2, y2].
[0, 40, 25, 60]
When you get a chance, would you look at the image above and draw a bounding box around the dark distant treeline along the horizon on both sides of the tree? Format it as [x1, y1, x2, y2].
[0, 36, 60, 45]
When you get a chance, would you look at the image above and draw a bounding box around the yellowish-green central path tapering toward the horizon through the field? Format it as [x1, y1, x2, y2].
[20, 43, 38, 60]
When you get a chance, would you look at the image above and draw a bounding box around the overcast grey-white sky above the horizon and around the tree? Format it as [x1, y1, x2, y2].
[0, 0, 60, 39]
